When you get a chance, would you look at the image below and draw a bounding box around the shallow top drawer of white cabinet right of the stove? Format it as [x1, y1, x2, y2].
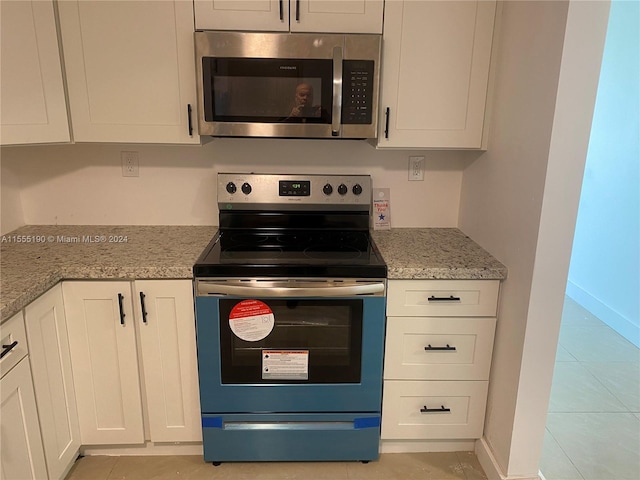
[387, 280, 500, 317]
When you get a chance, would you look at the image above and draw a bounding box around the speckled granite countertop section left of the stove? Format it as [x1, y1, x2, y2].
[0, 225, 217, 321]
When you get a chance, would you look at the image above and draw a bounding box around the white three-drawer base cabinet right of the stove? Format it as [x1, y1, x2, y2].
[381, 280, 499, 441]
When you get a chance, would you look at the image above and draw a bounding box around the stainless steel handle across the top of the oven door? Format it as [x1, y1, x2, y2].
[198, 282, 384, 298]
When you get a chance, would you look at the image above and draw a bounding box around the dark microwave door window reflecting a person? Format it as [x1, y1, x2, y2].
[202, 57, 333, 124]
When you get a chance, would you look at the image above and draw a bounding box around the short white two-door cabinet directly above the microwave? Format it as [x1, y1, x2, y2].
[194, 0, 383, 33]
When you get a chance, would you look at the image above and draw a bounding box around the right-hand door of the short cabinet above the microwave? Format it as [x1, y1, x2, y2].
[290, 0, 383, 33]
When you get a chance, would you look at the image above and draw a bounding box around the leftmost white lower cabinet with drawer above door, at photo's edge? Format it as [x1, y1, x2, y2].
[0, 312, 47, 480]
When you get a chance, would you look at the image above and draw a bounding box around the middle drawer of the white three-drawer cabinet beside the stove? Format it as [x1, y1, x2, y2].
[384, 317, 496, 380]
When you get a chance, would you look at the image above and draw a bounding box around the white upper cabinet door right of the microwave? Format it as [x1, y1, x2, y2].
[378, 0, 496, 148]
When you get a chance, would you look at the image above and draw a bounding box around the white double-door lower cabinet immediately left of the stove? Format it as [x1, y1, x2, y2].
[62, 280, 201, 445]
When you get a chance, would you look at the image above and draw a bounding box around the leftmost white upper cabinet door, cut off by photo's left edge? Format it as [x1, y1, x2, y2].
[0, 0, 69, 145]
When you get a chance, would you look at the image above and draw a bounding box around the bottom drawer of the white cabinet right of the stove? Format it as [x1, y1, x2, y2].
[381, 380, 489, 439]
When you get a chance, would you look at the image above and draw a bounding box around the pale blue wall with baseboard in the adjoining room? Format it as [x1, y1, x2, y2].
[567, 0, 640, 347]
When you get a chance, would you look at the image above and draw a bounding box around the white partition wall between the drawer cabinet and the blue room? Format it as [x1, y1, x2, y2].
[460, 1, 608, 479]
